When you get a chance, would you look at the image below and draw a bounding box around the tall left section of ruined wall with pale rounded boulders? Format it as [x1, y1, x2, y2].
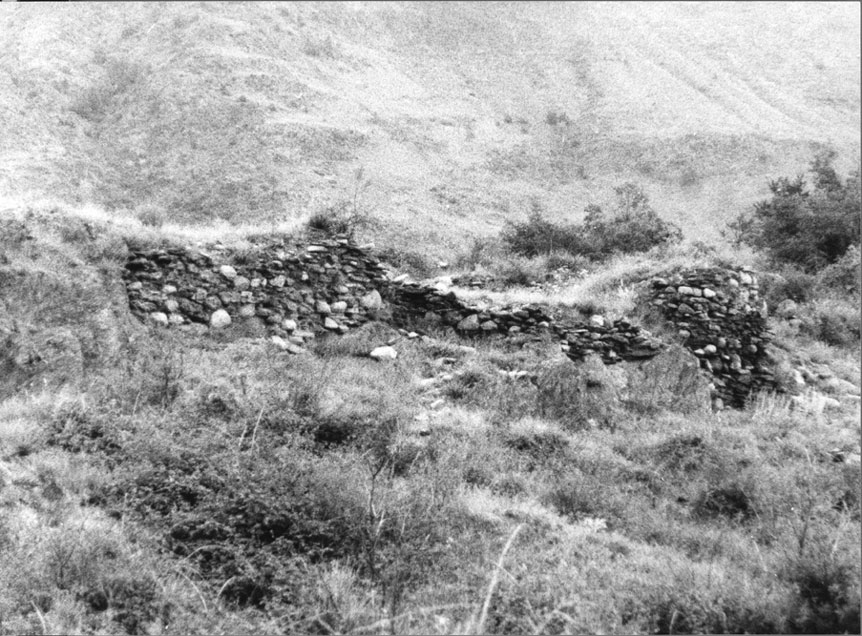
[124, 239, 386, 344]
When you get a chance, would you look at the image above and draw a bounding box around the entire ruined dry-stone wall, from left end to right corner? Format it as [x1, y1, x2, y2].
[124, 237, 774, 407]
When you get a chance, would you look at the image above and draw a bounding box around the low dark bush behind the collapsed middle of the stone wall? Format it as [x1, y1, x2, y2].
[501, 183, 682, 260]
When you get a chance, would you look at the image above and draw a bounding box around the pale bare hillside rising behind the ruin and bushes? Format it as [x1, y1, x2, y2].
[0, 2, 860, 254]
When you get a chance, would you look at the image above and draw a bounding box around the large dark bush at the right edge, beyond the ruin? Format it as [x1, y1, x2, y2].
[728, 152, 862, 272]
